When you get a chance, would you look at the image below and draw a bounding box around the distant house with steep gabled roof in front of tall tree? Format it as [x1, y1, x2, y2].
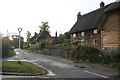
[30, 30, 61, 44]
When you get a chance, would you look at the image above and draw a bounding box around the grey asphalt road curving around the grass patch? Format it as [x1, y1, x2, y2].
[2, 50, 118, 80]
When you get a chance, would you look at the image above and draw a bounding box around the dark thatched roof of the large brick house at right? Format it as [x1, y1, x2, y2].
[70, 2, 120, 34]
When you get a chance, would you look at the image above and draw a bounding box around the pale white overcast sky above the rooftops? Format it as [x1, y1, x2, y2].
[0, 0, 116, 41]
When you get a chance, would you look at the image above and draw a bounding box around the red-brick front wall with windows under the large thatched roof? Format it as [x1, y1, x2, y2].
[71, 29, 101, 49]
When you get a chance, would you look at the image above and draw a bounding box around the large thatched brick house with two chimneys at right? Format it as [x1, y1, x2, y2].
[70, 1, 120, 49]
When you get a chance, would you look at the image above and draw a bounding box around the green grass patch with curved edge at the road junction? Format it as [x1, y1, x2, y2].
[2, 61, 48, 75]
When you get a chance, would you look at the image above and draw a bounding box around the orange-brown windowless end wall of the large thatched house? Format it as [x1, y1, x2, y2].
[101, 12, 120, 48]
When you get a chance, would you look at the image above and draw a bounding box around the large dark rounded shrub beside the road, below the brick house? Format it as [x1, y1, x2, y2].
[71, 46, 101, 62]
